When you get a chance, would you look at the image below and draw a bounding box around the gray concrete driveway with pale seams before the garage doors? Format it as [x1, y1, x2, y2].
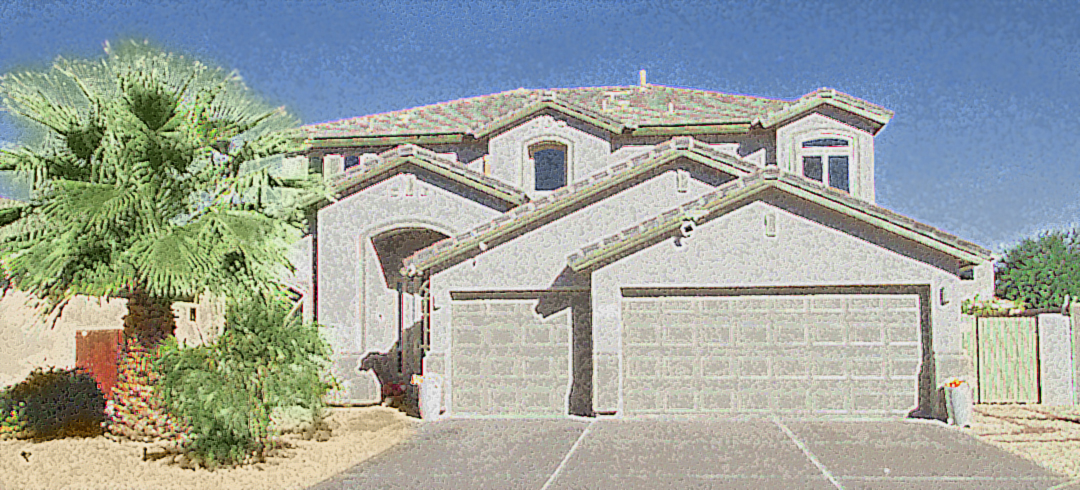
[313, 419, 1067, 490]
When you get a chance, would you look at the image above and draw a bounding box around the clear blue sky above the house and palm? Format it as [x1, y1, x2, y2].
[0, 0, 1080, 251]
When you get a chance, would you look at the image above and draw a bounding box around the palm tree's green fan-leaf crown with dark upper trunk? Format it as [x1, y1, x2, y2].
[0, 41, 327, 348]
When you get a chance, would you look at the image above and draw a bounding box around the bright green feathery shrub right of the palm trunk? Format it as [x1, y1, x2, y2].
[156, 300, 334, 468]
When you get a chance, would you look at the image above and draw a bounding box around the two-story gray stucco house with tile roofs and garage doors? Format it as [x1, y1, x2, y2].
[289, 72, 994, 417]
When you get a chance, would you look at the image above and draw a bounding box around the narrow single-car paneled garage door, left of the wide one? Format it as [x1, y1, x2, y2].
[450, 299, 571, 417]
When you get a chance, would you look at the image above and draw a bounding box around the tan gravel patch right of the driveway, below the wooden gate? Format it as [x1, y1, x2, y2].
[966, 404, 1080, 481]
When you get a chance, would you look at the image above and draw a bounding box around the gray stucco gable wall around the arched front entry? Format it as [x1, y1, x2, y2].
[318, 174, 499, 403]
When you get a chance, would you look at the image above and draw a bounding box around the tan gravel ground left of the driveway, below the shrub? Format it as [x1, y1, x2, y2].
[0, 407, 419, 490]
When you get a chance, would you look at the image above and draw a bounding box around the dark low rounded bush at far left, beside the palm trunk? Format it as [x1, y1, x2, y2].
[3, 367, 105, 440]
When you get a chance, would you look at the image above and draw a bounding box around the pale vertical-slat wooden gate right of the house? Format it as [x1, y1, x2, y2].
[964, 316, 1041, 404]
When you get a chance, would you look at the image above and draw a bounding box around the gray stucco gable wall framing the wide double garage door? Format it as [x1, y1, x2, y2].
[592, 202, 970, 410]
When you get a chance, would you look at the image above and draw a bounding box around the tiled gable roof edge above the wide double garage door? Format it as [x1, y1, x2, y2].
[567, 166, 993, 272]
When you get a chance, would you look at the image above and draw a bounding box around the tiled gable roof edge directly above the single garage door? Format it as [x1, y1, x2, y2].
[404, 137, 757, 275]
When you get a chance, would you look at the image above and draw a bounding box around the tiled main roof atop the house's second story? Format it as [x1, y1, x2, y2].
[302, 84, 892, 138]
